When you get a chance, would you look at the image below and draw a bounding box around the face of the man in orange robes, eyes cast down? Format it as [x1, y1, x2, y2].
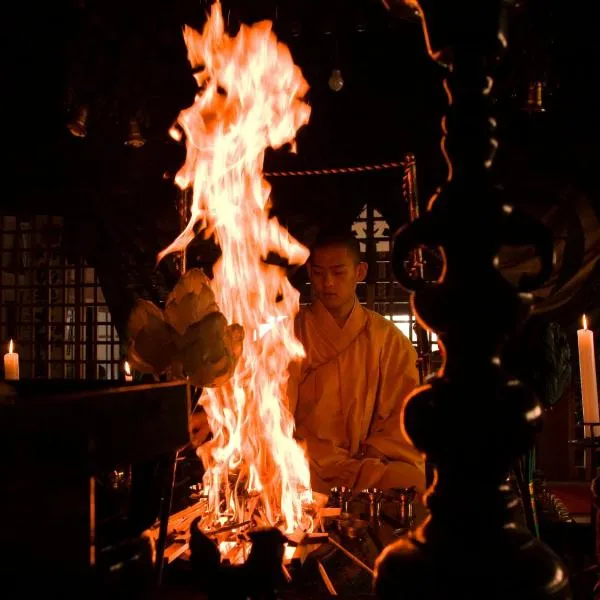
[307, 246, 367, 310]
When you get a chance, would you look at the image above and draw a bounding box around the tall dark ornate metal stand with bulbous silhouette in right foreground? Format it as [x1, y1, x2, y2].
[375, 0, 570, 600]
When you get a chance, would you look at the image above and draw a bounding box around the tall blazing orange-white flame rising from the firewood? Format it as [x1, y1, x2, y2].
[159, 2, 312, 531]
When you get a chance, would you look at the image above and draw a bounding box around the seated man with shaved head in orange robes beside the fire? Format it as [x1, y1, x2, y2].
[289, 227, 425, 493]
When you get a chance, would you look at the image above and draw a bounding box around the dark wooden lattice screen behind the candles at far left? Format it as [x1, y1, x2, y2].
[0, 215, 120, 379]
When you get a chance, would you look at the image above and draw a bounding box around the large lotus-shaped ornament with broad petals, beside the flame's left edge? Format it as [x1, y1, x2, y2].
[127, 269, 244, 387]
